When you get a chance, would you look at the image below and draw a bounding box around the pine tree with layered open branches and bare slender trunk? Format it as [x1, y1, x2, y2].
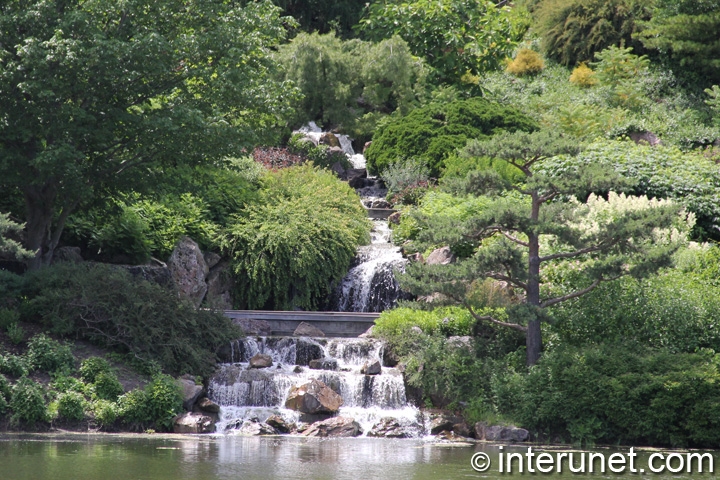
[402, 131, 688, 365]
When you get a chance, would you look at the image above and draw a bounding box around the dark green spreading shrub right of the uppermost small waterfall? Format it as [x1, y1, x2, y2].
[365, 98, 536, 177]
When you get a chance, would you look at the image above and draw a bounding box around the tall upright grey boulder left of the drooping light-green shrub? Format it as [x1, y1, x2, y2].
[168, 237, 210, 307]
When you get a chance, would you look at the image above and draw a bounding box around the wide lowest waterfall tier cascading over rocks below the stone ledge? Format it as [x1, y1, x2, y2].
[208, 337, 424, 437]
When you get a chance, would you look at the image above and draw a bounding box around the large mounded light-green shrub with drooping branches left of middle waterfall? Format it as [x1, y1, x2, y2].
[223, 165, 370, 310]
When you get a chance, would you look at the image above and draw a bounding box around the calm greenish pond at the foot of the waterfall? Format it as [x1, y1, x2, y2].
[0, 434, 720, 480]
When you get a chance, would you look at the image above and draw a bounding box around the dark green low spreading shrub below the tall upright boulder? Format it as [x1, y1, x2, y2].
[23, 263, 240, 374]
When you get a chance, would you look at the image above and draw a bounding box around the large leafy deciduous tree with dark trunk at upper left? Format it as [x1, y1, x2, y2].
[0, 0, 292, 268]
